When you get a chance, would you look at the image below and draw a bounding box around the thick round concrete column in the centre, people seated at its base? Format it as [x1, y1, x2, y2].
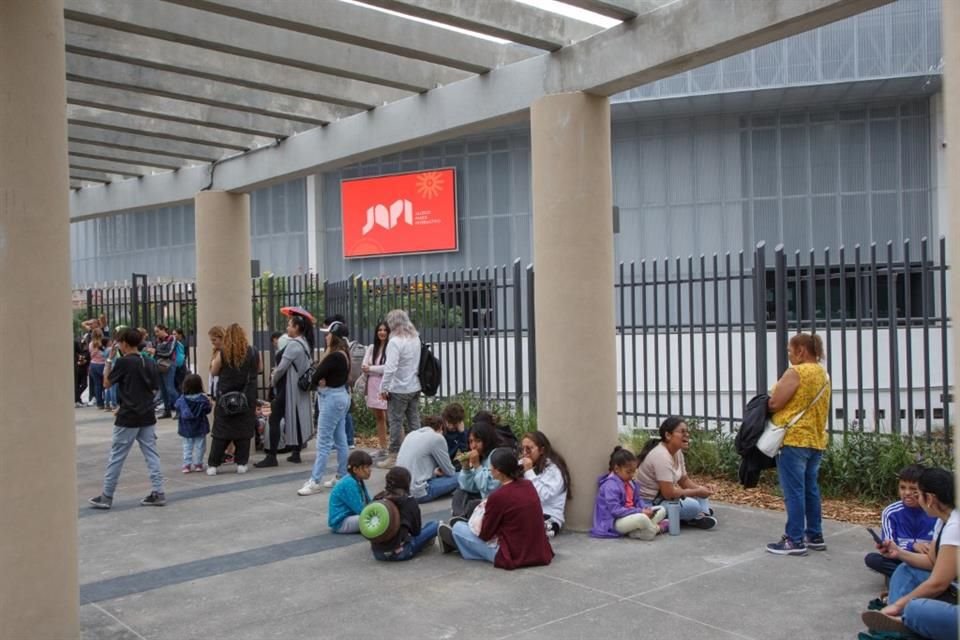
[530, 93, 617, 531]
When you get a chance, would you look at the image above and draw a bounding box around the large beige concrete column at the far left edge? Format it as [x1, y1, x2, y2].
[0, 0, 80, 640]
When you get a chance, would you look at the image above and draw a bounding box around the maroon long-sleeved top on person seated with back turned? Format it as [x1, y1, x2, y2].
[480, 479, 553, 569]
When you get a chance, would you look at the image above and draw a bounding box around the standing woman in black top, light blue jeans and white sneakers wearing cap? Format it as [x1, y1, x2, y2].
[297, 321, 350, 496]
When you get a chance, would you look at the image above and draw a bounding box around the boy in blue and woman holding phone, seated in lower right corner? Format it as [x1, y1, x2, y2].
[861, 465, 960, 640]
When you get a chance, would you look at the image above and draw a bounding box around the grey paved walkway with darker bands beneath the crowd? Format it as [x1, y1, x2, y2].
[77, 409, 882, 640]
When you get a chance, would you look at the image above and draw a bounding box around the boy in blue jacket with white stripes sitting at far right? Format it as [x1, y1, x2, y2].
[863, 464, 937, 578]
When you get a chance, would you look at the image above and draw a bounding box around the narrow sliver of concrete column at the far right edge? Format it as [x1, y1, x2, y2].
[940, 2, 960, 516]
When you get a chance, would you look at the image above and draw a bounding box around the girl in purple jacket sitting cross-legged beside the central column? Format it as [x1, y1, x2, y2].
[590, 447, 667, 540]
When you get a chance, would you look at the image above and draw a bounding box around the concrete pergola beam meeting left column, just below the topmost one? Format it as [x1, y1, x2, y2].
[66, 21, 410, 109]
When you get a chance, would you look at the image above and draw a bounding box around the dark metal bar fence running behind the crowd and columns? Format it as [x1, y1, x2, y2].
[77, 239, 953, 437]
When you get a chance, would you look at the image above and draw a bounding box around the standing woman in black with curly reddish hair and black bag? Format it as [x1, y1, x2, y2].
[207, 323, 262, 476]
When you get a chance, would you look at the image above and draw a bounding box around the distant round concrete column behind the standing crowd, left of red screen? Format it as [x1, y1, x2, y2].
[194, 191, 253, 382]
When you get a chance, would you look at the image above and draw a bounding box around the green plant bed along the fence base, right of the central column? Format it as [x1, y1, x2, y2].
[623, 420, 954, 504]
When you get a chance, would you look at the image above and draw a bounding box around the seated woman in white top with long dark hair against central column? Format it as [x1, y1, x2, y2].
[520, 431, 573, 538]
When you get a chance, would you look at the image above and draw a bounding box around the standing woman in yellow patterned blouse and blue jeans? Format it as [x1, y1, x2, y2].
[767, 333, 830, 556]
